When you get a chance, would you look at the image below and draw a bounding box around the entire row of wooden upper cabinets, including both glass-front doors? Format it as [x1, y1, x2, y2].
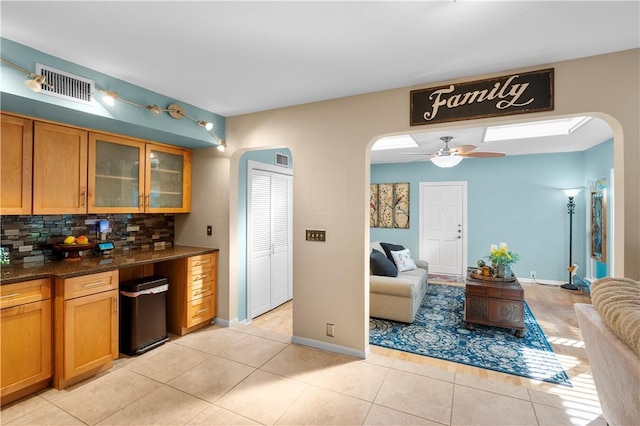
[0, 114, 191, 215]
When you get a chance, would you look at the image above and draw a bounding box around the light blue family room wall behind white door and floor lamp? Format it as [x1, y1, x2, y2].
[370, 141, 613, 281]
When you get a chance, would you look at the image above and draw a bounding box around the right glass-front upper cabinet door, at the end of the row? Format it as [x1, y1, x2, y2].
[145, 144, 191, 213]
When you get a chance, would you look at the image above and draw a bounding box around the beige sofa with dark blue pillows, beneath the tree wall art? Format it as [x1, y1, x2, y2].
[369, 242, 429, 323]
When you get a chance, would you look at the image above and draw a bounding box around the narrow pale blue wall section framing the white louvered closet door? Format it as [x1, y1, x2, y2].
[238, 148, 293, 321]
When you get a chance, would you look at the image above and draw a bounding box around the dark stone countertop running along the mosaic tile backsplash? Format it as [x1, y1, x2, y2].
[0, 246, 218, 285]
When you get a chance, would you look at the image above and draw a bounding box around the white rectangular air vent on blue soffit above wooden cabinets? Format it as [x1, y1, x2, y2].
[36, 64, 95, 105]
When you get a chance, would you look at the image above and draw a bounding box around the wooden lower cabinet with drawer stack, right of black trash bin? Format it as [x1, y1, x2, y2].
[154, 252, 218, 336]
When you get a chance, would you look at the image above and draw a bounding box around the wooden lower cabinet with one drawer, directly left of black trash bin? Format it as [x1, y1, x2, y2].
[53, 271, 118, 389]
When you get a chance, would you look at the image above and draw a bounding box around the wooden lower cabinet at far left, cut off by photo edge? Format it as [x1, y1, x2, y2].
[0, 279, 52, 404]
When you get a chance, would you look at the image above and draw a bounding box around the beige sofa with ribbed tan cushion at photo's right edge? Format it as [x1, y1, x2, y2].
[574, 278, 640, 426]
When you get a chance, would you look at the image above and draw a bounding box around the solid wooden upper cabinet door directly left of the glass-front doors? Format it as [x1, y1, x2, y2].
[33, 122, 87, 214]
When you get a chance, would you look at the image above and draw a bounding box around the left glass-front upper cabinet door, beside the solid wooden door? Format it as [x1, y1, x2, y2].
[88, 133, 146, 213]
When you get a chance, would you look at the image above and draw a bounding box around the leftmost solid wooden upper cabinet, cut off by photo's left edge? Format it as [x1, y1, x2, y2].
[0, 114, 33, 215]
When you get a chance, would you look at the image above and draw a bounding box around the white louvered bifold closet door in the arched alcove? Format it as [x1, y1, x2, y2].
[248, 166, 293, 319]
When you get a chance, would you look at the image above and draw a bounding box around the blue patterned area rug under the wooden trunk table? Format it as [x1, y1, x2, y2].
[369, 283, 572, 386]
